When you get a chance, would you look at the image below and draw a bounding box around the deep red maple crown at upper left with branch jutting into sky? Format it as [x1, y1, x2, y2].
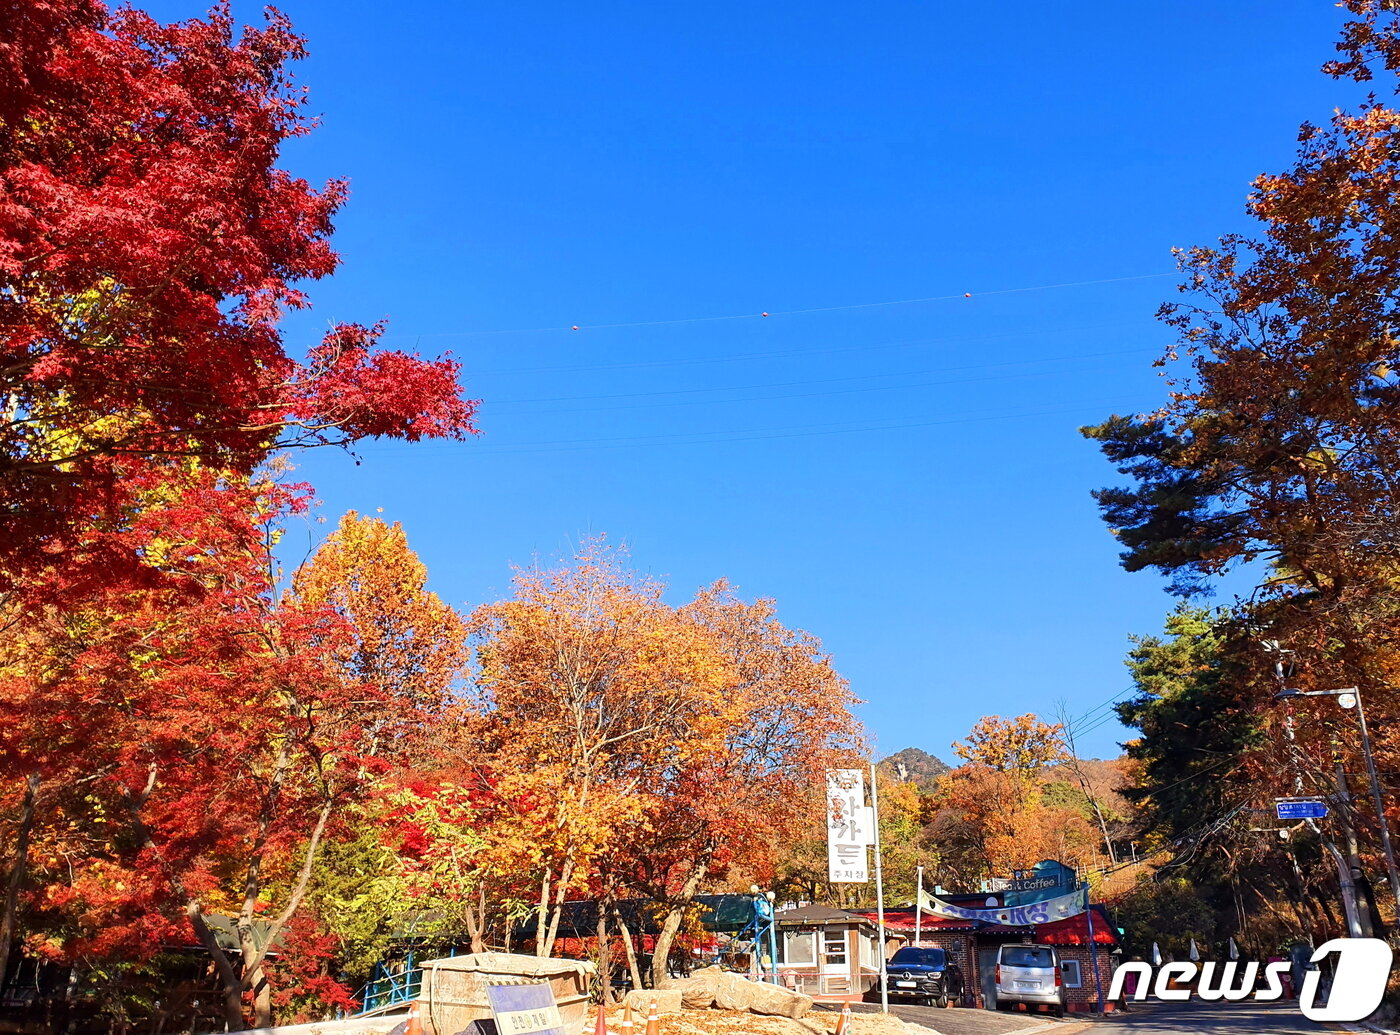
[0, 0, 475, 581]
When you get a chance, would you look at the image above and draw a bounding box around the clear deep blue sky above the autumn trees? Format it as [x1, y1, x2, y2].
[151, 0, 1351, 758]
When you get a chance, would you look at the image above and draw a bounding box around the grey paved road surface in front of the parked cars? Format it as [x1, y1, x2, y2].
[812, 1000, 1330, 1035]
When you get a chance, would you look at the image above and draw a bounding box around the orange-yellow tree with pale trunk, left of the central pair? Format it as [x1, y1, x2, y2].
[472, 542, 732, 955]
